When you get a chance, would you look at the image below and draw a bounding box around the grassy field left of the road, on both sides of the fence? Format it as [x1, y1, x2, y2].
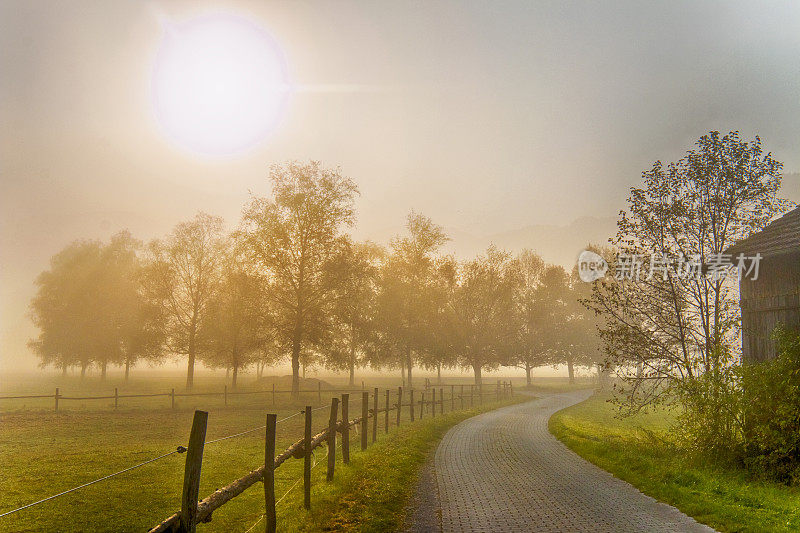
[0, 374, 524, 532]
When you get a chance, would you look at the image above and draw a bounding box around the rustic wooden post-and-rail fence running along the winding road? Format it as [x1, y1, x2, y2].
[149, 381, 513, 533]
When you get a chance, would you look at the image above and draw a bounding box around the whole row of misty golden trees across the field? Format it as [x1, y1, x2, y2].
[31, 162, 600, 392]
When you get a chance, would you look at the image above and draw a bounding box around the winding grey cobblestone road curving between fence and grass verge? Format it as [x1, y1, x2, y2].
[428, 391, 713, 533]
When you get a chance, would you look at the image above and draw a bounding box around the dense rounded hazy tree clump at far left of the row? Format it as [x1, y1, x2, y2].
[29, 231, 162, 378]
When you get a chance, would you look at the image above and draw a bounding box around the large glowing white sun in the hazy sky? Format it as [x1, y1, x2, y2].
[152, 14, 290, 155]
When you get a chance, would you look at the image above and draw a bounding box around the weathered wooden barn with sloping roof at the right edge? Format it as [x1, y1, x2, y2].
[727, 207, 800, 361]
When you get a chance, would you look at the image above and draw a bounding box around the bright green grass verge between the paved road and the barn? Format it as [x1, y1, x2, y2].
[550, 390, 800, 532]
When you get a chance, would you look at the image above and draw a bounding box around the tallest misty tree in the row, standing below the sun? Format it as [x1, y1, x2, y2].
[238, 161, 358, 396]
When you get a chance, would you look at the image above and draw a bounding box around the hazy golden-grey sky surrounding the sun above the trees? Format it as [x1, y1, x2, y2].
[0, 0, 800, 369]
